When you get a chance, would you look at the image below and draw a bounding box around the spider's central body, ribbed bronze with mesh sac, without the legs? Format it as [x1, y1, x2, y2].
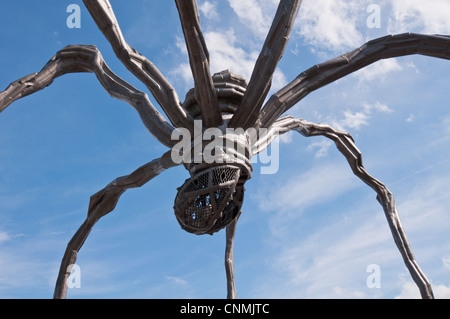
[174, 71, 252, 235]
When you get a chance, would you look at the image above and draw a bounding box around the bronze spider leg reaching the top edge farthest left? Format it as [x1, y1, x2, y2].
[83, 0, 194, 131]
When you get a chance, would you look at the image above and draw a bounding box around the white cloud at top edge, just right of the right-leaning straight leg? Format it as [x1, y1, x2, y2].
[296, 0, 365, 51]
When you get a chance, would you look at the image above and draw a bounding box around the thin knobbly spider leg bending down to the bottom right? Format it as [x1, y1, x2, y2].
[257, 116, 434, 299]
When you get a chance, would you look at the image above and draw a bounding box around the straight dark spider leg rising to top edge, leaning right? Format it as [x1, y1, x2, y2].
[229, 0, 302, 129]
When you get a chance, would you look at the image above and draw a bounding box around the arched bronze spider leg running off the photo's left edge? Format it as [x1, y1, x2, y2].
[0, 45, 174, 147]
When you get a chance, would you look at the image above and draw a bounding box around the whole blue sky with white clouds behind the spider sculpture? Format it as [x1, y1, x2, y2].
[0, 0, 450, 298]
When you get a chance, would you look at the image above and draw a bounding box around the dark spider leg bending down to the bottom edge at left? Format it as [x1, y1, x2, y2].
[53, 151, 178, 299]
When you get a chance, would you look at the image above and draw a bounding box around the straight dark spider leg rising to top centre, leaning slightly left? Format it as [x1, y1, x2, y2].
[175, 0, 222, 128]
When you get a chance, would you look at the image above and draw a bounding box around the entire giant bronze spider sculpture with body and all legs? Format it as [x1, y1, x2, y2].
[0, 0, 450, 298]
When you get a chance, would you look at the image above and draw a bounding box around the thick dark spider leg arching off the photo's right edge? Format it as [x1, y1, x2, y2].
[259, 33, 450, 127]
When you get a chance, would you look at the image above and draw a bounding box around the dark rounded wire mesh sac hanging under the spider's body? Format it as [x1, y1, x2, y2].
[174, 165, 243, 235]
